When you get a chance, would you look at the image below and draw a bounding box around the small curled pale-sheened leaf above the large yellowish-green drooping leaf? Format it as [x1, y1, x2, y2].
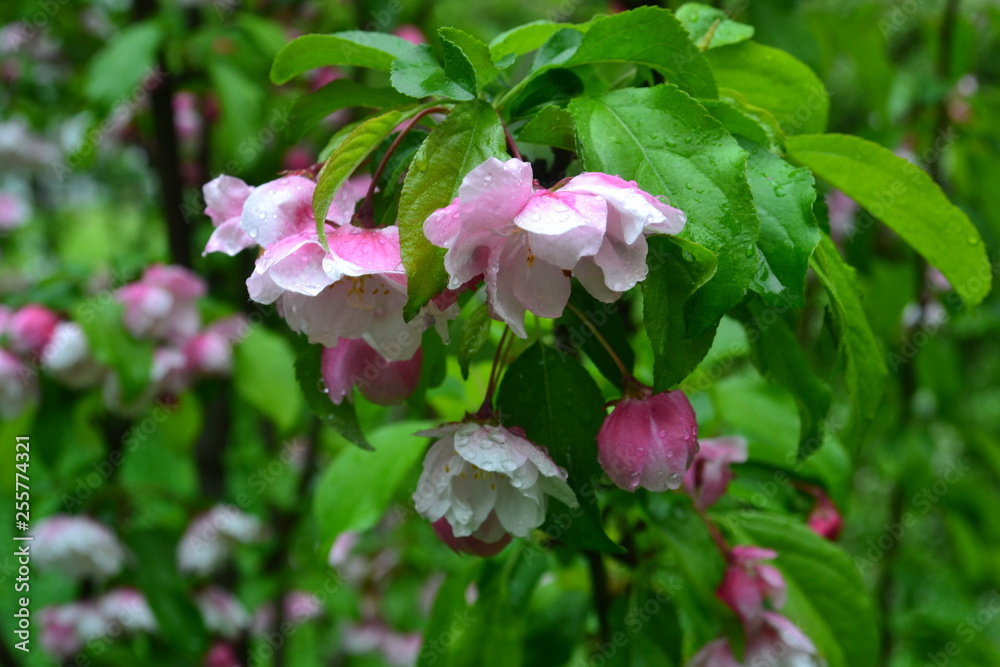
[389, 42, 478, 100]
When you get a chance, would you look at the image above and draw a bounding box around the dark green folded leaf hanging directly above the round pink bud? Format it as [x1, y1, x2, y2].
[642, 237, 718, 391]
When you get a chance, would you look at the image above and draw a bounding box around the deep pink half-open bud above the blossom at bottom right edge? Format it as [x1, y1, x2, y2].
[718, 545, 785, 634]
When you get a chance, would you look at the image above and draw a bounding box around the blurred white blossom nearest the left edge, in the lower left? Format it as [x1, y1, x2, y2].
[32, 514, 125, 579]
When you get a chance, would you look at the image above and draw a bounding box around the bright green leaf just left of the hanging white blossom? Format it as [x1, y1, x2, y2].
[313, 421, 432, 553]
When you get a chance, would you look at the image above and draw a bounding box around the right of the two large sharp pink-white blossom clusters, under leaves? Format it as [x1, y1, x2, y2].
[424, 158, 686, 338]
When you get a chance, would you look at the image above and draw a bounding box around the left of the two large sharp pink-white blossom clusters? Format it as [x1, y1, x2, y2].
[206, 175, 457, 361]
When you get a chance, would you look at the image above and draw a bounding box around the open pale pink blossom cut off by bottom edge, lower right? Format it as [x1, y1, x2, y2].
[688, 612, 826, 667]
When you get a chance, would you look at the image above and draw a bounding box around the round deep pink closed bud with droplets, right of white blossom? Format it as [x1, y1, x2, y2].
[597, 389, 698, 491]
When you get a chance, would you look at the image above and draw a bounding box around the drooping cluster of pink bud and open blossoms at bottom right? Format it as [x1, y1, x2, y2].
[689, 545, 826, 667]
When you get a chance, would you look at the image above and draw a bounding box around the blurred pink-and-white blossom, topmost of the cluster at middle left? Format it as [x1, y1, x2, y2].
[116, 264, 206, 341]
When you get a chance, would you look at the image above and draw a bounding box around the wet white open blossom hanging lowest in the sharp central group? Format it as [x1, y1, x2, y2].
[413, 424, 577, 543]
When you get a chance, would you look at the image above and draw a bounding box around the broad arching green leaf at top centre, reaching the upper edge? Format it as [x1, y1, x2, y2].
[563, 7, 716, 97]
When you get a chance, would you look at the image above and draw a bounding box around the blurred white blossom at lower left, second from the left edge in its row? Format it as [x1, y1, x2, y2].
[177, 505, 263, 576]
